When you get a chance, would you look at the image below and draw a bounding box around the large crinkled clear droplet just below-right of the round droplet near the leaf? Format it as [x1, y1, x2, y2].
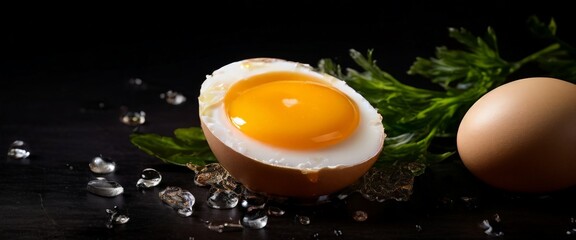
[158, 186, 196, 217]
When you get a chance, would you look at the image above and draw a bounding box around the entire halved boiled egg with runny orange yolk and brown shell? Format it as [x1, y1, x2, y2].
[198, 58, 386, 198]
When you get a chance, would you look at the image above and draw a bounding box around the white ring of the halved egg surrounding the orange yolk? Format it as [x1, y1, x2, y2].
[198, 58, 386, 171]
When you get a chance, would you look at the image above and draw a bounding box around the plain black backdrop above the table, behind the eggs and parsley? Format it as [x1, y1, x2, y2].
[2, 0, 575, 86]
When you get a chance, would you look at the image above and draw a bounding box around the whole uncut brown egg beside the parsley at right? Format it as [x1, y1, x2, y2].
[457, 77, 576, 193]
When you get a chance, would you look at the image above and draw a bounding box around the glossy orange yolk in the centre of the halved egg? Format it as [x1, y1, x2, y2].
[224, 72, 360, 150]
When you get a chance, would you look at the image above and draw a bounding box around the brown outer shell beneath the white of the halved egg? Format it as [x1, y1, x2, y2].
[201, 123, 384, 201]
